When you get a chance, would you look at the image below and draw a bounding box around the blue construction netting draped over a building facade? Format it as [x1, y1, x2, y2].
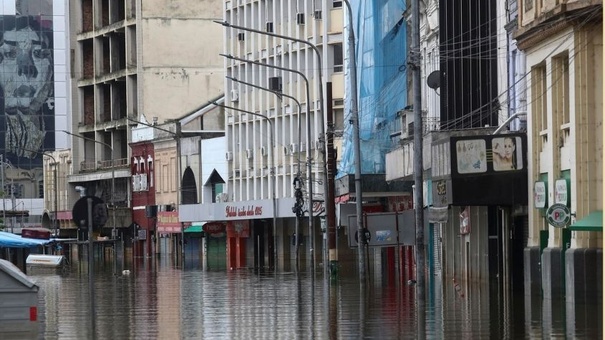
[336, 0, 407, 178]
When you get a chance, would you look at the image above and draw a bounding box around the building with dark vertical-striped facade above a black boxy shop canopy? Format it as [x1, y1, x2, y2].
[386, 0, 527, 293]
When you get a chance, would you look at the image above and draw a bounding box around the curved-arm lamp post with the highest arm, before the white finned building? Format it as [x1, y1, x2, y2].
[214, 20, 334, 271]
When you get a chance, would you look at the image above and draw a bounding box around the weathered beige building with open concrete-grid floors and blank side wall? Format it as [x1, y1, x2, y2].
[64, 0, 223, 241]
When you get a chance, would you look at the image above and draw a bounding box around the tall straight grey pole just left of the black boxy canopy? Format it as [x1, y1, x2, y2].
[409, 0, 425, 306]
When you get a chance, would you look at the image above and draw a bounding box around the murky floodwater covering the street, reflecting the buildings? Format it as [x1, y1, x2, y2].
[24, 260, 603, 339]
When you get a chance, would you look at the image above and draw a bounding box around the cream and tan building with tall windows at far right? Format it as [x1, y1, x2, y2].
[515, 0, 603, 308]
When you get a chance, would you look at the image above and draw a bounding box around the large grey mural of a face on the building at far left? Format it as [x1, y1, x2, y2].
[0, 16, 53, 158]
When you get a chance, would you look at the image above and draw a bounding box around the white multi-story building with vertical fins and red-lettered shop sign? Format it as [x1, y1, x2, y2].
[181, 0, 344, 268]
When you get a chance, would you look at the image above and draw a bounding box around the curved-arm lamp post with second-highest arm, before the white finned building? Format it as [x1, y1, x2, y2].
[220, 54, 318, 272]
